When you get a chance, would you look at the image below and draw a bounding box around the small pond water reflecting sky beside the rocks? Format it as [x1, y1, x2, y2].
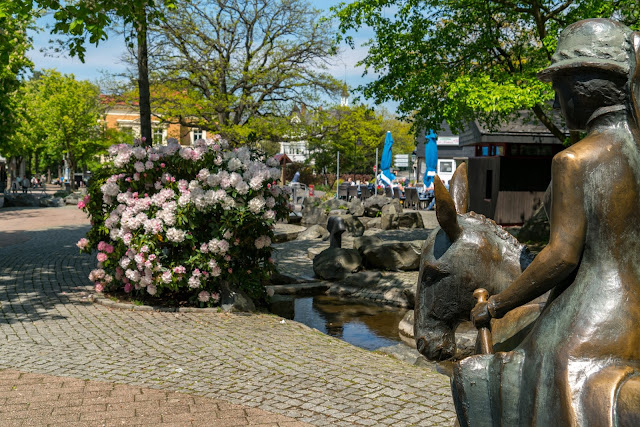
[271, 295, 406, 350]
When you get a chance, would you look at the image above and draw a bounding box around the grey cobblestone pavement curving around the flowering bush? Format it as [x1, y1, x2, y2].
[0, 208, 454, 426]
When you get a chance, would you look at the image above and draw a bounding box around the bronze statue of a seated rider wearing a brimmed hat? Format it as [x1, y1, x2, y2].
[450, 19, 640, 426]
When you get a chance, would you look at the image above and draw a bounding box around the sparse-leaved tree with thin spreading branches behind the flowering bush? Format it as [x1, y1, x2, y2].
[150, 0, 343, 144]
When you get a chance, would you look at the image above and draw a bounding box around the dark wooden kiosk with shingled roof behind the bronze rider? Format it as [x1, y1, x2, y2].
[460, 116, 564, 225]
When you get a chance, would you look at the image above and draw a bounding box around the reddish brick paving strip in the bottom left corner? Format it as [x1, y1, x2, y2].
[0, 369, 310, 427]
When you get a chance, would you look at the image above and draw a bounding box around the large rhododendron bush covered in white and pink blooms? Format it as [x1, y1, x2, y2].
[78, 137, 289, 306]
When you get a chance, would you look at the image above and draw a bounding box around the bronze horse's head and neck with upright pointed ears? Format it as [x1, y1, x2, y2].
[414, 163, 546, 361]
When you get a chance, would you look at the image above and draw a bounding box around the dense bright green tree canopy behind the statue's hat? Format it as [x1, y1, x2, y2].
[332, 0, 638, 139]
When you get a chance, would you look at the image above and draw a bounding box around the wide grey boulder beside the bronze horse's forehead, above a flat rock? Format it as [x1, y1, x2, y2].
[360, 242, 421, 271]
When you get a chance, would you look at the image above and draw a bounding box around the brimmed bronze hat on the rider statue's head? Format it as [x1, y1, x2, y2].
[538, 18, 630, 82]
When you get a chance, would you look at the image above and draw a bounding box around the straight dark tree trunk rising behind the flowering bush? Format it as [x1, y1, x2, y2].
[137, 4, 153, 146]
